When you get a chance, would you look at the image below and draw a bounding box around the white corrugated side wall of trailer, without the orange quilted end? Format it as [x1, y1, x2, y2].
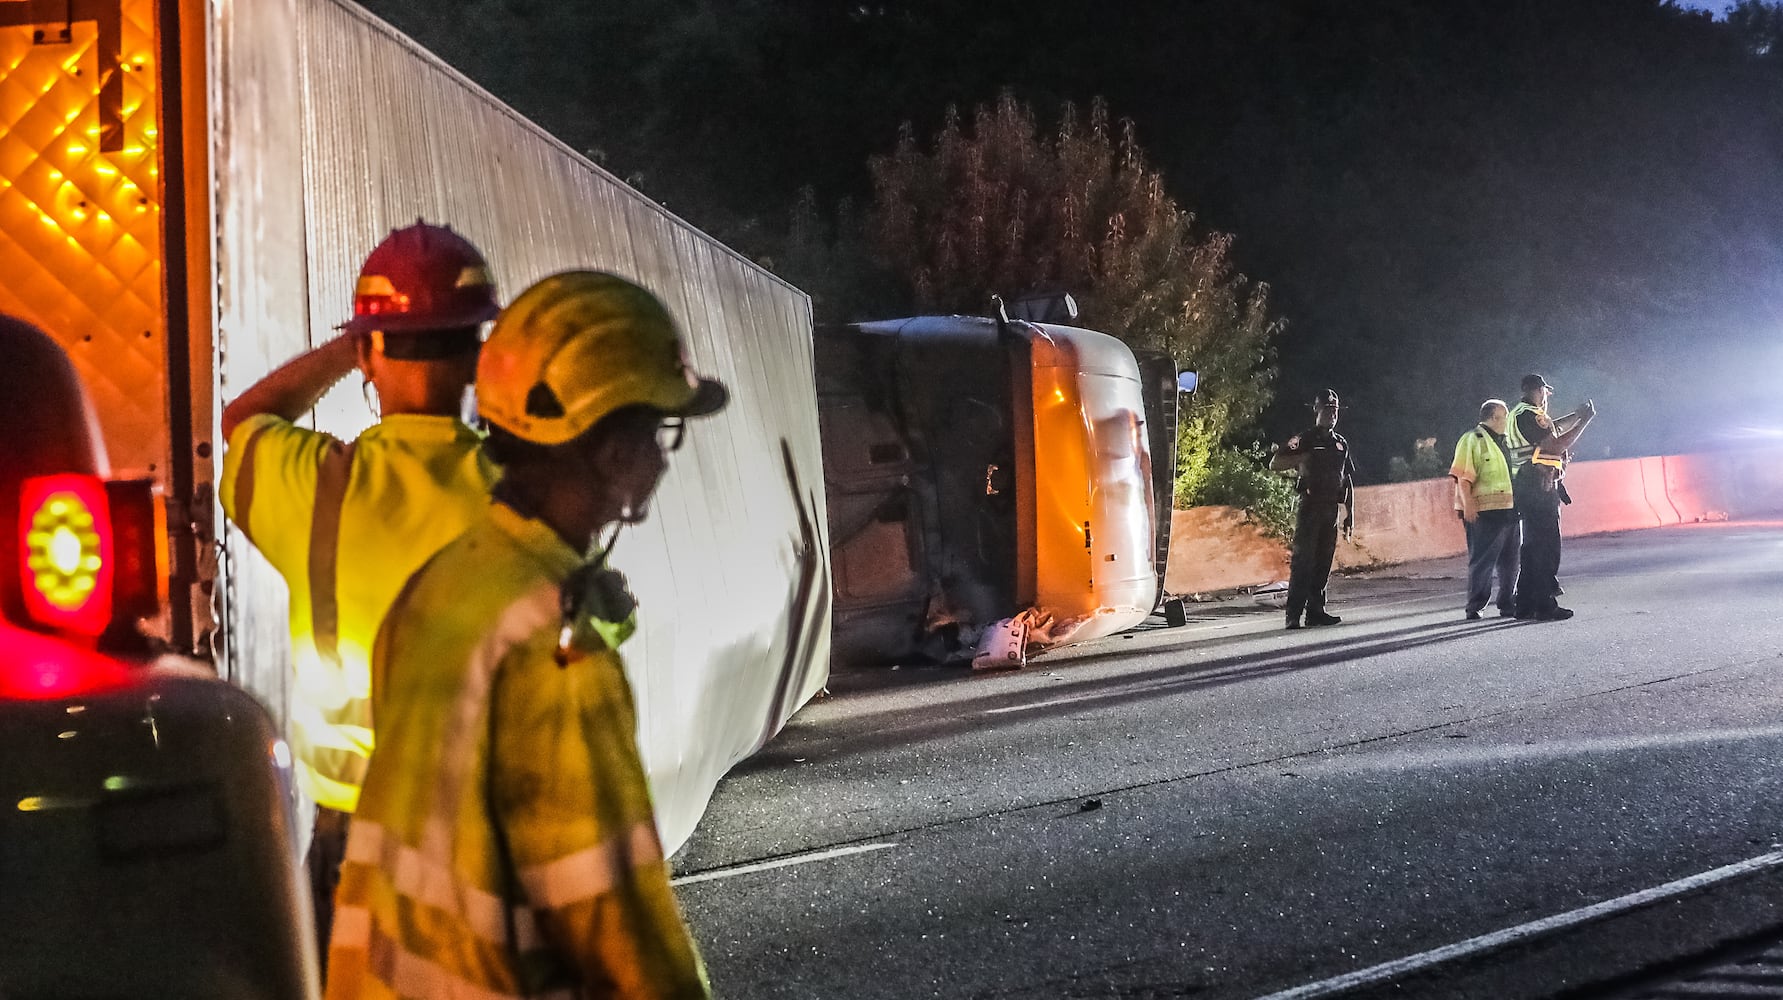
[214, 0, 829, 848]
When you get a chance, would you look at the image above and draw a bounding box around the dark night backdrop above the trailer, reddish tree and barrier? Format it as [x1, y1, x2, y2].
[367, 0, 1783, 480]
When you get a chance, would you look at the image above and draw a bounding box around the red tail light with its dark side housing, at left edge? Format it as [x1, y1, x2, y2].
[18, 474, 160, 636]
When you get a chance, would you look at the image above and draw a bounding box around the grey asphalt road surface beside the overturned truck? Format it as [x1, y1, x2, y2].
[676, 522, 1783, 1000]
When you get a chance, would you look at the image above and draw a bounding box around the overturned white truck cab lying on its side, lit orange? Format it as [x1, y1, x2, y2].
[817, 310, 1179, 665]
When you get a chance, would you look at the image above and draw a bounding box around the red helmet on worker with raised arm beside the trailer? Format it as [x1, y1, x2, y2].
[341, 219, 501, 333]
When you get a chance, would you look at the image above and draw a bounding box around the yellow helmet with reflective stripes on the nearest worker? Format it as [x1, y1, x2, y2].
[476, 271, 729, 446]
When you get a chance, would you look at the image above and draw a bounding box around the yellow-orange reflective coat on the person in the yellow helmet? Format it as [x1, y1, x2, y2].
[328, 503, 708, 1000]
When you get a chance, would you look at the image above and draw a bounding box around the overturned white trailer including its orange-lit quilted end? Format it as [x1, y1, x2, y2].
[0, 0, 831, 848]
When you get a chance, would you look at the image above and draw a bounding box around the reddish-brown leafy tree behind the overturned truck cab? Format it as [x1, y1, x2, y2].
[867, 93, 1282, 494]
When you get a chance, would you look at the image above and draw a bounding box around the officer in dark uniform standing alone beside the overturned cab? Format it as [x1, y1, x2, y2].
[1269, 389, 1355, 629]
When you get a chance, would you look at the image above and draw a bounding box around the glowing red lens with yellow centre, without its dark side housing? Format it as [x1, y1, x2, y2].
[18, 474, 114, 636]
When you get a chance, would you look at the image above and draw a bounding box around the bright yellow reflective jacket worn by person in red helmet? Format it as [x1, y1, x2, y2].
[218, 414, 496, 813]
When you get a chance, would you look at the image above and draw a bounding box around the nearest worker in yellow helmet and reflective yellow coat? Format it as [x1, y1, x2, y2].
[328, 271, 726, 1000]
